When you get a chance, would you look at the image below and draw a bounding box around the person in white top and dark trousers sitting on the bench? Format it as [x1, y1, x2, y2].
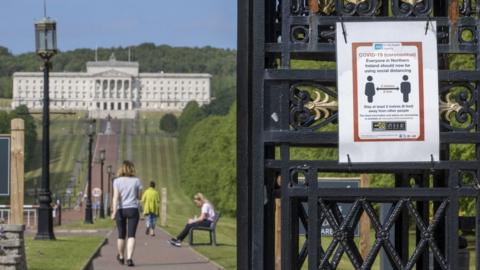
[168, 193, 215, 247]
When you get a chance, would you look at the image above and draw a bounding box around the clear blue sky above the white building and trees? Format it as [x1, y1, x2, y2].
[0, 0, 237, 54]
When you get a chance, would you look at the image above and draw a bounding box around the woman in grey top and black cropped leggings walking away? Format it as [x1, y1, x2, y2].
[112, 160, 142, 266]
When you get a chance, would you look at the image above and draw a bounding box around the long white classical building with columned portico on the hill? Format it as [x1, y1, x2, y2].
[12, 54, 212, 118]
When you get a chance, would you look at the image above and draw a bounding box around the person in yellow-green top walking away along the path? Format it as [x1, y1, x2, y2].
[142, 181, 160, 236]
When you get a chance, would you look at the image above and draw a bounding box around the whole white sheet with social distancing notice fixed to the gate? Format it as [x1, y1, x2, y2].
[337, 21, 439, 163]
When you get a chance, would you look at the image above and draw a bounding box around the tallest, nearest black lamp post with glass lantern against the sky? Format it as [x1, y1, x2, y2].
[35, 16, 57, 240]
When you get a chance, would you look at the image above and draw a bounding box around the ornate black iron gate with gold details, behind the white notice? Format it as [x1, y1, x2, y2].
[237, 0, 480, 269]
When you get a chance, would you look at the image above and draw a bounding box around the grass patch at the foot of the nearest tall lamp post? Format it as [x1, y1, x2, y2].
[25, 236, 104, 270]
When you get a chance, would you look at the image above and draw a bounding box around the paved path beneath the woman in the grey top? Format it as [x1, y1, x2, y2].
[93, 223, 222, 270]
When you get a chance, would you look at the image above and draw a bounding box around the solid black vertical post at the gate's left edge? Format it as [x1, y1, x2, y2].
[237, 0, 253, 269]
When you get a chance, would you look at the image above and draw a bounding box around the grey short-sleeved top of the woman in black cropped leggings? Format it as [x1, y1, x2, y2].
[113, 176, 142, 209]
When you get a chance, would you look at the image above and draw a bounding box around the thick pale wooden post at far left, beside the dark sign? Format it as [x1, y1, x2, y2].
[10, 118, 25, 225]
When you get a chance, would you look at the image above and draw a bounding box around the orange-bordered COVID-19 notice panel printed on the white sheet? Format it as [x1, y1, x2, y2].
[352, 42, 425, 141]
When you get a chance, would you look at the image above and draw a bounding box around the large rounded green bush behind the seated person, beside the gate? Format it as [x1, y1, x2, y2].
[180, 103, 236, 215]
